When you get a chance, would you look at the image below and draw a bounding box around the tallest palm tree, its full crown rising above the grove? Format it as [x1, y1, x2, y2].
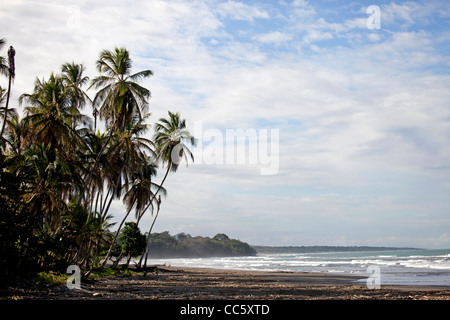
[86, 48, 153, 191]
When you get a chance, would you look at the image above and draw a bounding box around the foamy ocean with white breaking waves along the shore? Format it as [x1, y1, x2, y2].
[140, 249, 450, 286]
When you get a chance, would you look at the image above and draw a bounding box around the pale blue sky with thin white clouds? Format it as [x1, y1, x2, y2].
[0, 0, 450, 248]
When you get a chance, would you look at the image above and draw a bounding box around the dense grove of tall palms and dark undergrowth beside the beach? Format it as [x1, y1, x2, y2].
[0, 39, 195, 281]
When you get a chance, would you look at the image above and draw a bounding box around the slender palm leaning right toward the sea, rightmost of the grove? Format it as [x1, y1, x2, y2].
[144, 111, 197, 268]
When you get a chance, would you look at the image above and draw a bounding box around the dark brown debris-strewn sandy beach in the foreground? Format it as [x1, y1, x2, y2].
[0, 267, 450, 300]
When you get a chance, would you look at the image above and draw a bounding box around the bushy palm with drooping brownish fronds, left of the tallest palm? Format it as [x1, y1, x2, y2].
[19, 70, 89, 240]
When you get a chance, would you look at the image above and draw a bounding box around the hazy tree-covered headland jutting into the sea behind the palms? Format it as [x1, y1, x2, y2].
[145, 231, 256, 258]
